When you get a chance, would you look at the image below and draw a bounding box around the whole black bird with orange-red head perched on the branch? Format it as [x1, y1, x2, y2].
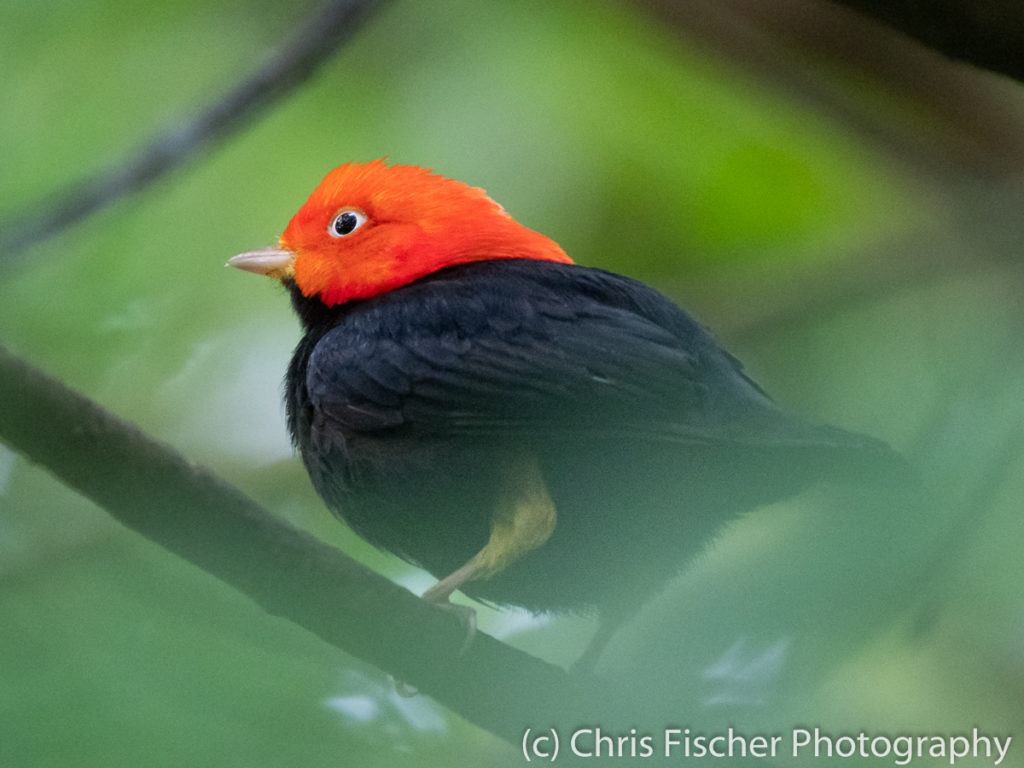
[228, 160, 898, 664]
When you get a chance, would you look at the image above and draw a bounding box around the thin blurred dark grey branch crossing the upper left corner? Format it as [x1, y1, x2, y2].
[0, 0, 382, 259]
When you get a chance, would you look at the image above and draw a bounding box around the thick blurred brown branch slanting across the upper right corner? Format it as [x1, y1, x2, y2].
[632, 0, 1024, 175]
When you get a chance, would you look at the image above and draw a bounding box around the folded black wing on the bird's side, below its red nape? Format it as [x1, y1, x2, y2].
[306, 262, 845, 444]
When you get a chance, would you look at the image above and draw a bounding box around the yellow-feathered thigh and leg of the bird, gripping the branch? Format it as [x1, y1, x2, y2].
[423, 457, 557, 603]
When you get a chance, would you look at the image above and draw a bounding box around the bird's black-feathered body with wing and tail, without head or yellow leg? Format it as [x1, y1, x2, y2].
[287, 260, 892, 610]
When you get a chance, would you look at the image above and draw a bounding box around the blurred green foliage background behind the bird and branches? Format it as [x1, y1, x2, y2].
[0, 0, 1024, 766]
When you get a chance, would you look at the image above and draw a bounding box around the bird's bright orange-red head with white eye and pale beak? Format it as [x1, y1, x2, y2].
[228, 160, 571, 306]
